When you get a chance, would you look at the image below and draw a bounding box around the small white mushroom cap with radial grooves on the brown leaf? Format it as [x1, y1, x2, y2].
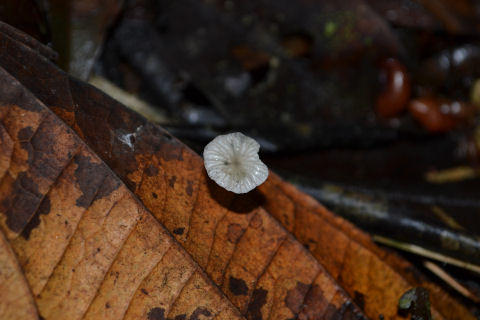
[203, 132, 268, 193]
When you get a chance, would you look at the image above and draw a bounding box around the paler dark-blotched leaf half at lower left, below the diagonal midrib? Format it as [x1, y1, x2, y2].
[0, 69, 242, 319]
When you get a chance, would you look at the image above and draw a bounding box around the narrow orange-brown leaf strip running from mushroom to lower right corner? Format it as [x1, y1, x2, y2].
[261, 175, 474, 320]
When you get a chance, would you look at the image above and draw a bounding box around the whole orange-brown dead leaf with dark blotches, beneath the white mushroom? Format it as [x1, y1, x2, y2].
[0, 23, 474, 319]
